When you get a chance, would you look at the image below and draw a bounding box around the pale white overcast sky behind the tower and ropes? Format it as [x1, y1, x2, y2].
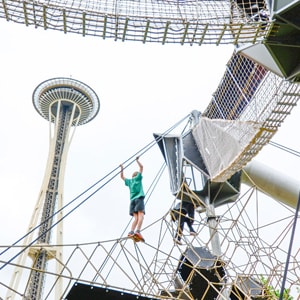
[0, 20, 300, 296]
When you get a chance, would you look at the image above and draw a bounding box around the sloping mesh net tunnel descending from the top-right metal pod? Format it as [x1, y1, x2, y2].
[203, 53, 300, 181]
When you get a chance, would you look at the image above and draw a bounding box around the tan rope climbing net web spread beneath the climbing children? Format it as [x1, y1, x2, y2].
[0, 170, 300, 300]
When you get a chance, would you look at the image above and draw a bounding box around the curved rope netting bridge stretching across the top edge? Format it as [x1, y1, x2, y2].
[0, 0, 272, 45]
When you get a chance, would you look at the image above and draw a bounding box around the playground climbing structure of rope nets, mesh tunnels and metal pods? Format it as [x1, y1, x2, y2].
[0, 0, 300, 299]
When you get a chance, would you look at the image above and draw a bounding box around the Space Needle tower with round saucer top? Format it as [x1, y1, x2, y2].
[6, 77, 100, 300]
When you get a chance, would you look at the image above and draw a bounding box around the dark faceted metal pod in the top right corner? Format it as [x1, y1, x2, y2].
[237, 0, 300, 82]
